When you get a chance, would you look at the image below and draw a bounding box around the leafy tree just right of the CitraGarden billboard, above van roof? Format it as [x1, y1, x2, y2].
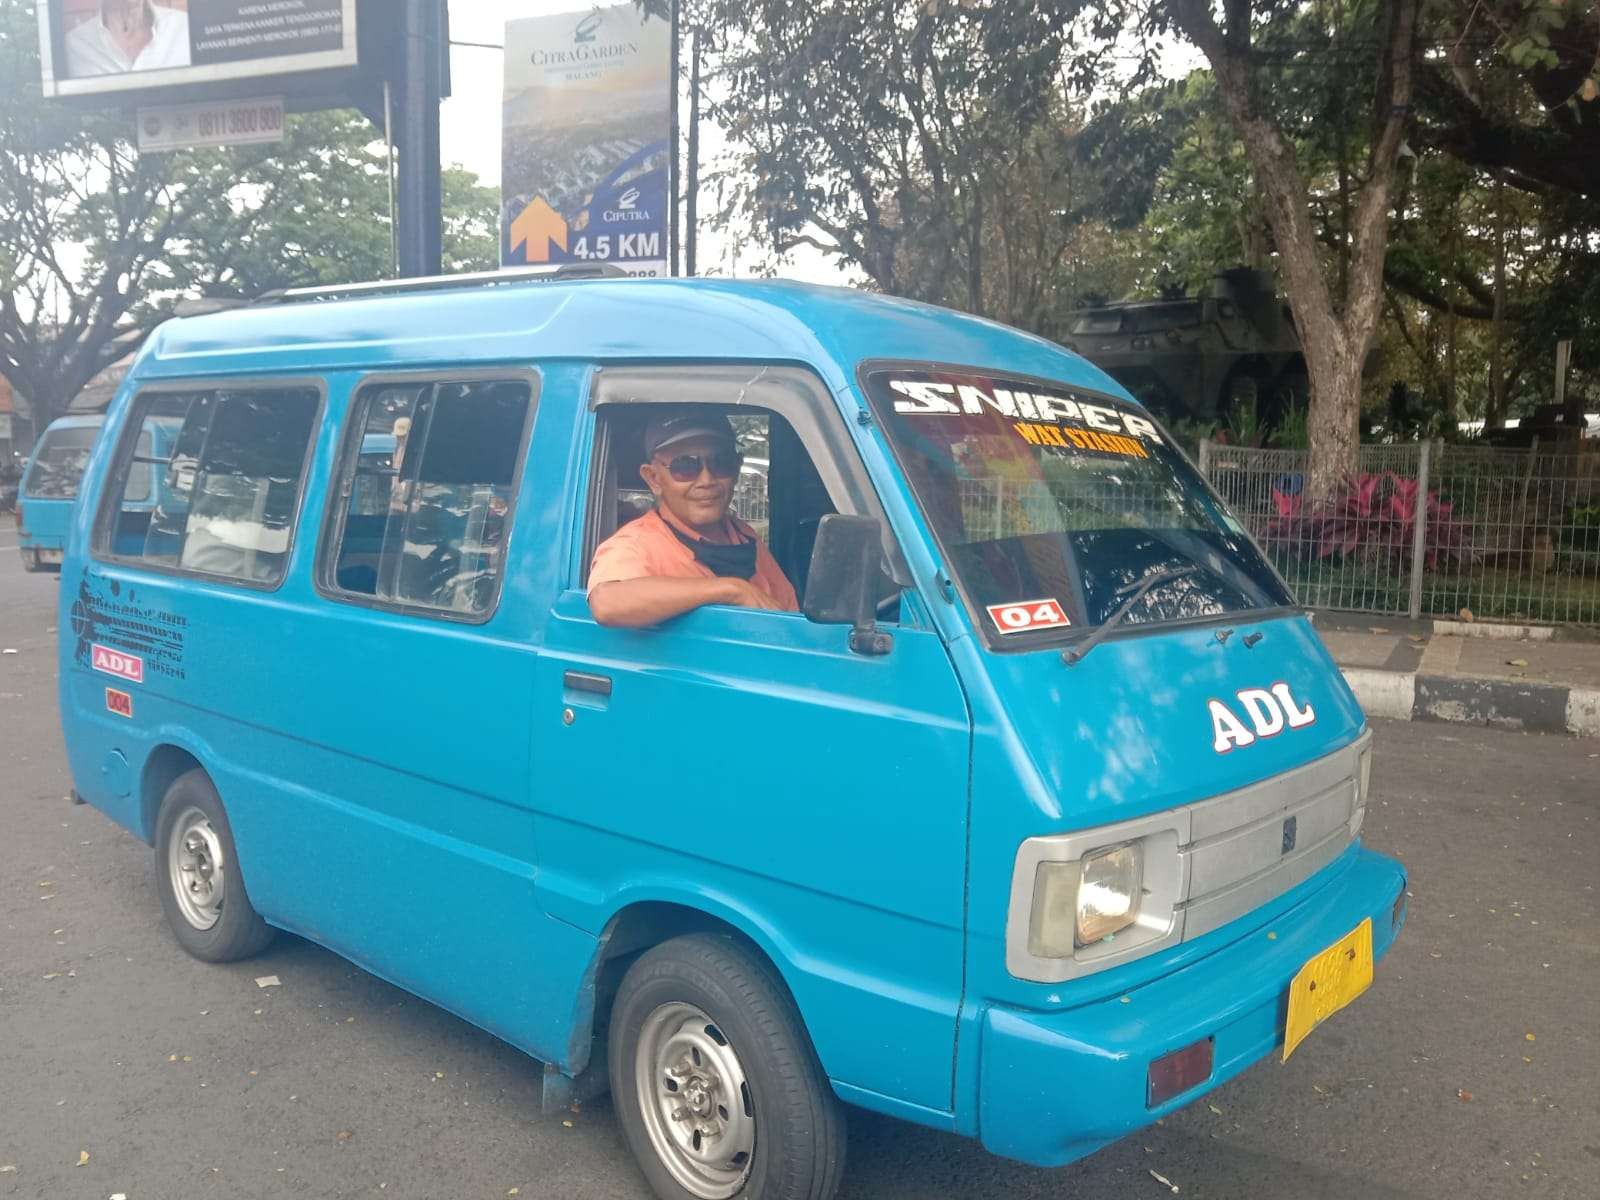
[690, 0, 1078, 312]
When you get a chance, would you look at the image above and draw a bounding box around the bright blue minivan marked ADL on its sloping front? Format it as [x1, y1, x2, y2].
[61, 277, 1406, 1200]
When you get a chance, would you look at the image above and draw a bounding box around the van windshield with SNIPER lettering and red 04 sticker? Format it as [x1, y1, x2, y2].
[866, 370, 1293, 643]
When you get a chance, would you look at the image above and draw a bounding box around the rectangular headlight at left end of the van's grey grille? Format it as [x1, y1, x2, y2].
[1027, 842, 1144, 958]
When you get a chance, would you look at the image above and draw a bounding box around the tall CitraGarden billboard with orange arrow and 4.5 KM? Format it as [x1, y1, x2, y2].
[501, 3, 672, 275]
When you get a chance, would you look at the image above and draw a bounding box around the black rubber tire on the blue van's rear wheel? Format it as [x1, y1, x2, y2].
[155, 770, 274, 963]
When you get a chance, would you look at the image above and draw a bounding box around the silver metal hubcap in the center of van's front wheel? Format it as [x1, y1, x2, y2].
[634, 1003, 755, 1200]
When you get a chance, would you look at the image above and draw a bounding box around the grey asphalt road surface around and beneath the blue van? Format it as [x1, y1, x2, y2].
[0, 534, 1600, 1200]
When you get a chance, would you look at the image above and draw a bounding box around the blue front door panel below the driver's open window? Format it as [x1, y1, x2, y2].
[533, 592, 971, 1120]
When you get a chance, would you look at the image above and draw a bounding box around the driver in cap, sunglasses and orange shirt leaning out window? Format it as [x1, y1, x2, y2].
[589, 406, 800, 629]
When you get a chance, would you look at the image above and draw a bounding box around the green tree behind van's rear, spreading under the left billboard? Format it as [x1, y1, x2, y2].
[0, 0, 499, 429]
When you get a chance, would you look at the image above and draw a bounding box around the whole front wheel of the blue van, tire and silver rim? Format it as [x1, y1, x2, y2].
[610, 934, 845, 1200]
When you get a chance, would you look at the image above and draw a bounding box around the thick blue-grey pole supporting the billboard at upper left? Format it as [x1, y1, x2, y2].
[395, 0, 450, 278]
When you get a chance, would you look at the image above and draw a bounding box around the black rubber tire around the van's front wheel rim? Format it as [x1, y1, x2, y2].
[610, 934, 845, 1200]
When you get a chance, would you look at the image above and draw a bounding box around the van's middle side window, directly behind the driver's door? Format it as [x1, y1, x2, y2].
[322, 379, 533, 619]
